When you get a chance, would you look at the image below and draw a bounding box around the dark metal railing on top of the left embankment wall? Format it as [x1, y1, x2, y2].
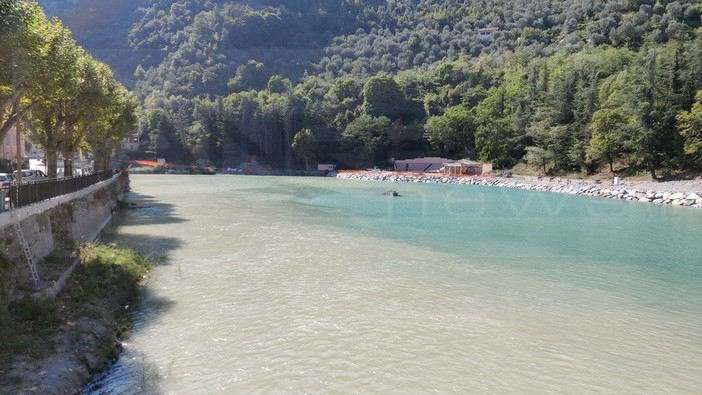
[7, 170, 113, 208]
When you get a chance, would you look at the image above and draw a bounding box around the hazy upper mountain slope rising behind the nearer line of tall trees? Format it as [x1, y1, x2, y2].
[40, 0, 701, 94]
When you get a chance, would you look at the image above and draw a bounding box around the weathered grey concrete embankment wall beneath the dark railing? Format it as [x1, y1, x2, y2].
[0, 175, 129, 301]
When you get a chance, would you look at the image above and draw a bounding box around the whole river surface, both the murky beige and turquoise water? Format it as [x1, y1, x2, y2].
[86, 175, 702, 394]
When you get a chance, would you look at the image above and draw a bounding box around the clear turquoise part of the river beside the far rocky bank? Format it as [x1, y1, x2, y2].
[276, 179, 702, 312]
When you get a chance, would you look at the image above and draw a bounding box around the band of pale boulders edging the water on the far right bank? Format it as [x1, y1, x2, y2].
[337, 172, 702, 208]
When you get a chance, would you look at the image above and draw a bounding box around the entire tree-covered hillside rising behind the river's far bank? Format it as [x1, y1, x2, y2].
[43, 0, 702, 176]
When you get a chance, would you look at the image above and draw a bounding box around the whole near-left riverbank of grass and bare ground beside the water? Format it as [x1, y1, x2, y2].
[0, 244, 153, 394]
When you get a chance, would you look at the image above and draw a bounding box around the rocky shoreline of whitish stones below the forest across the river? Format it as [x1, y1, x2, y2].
[336, 172, 702, 208]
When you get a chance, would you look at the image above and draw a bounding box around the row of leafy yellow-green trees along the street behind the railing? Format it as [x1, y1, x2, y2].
[0, 0, 138, 177]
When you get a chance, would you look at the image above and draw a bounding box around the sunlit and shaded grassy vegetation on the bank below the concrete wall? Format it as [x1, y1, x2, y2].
[0, 243, 155, 376]
